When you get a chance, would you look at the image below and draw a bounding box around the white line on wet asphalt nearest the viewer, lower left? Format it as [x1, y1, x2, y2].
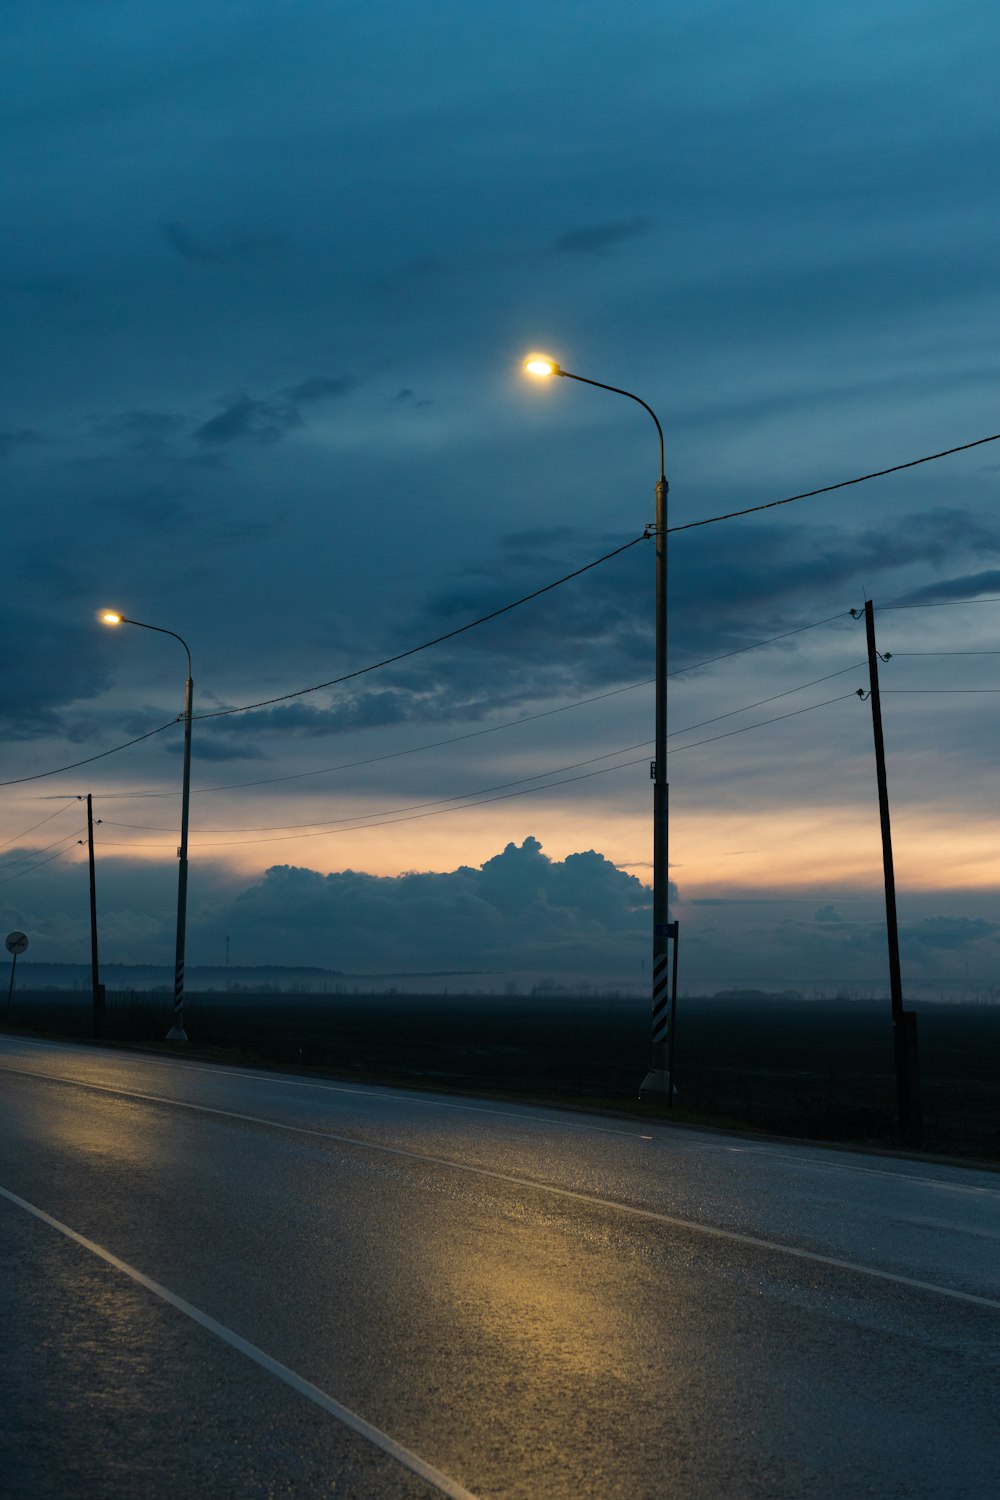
[0, 1187, 477, 1500]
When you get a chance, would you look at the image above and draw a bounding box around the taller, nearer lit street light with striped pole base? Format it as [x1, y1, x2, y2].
[523, 353, 678, 1103]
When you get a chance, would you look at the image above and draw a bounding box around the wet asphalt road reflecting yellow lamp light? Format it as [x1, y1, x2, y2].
[0, 1038, 1000, 1500]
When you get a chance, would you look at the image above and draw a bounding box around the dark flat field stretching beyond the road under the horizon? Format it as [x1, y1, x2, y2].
[4, 990, 1000, 1161]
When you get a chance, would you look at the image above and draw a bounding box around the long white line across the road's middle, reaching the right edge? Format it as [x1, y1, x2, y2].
[7, 1064, 1000, 1313]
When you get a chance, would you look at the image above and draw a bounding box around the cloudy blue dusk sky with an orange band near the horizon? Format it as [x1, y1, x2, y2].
[0, 0, 1000, 998]
